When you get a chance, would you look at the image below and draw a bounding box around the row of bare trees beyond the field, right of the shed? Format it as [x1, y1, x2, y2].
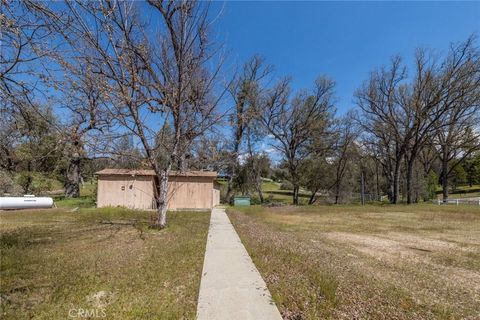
[218, 37, 480, 204]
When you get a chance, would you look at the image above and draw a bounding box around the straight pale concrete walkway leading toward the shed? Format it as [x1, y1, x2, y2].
[197, 208, 282, 320]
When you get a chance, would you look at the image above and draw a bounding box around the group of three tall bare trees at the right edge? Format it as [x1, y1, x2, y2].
[356, 37, 480, 203]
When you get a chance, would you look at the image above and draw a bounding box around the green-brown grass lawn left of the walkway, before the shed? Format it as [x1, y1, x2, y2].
[0, 206, 210, 319]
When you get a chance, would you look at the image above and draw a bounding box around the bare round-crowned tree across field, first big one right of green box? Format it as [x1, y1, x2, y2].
[260, 77, 334, 205]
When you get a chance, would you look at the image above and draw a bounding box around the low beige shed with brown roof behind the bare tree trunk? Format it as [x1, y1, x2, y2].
[96, 169, 220, 210]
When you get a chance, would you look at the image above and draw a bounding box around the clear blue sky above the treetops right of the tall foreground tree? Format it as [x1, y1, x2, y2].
[212, 1, 480, 114]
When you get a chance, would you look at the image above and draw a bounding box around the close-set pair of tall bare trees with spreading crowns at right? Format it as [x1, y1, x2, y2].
[356, 38, 478, 203]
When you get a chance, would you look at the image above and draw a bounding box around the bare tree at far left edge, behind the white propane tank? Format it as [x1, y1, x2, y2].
[0, 1, 66, 192]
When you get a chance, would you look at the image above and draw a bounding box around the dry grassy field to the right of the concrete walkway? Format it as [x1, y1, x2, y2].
[228, 205, 480, 319]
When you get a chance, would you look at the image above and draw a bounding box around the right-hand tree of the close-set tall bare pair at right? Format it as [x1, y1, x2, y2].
[401, 37, 480, 203]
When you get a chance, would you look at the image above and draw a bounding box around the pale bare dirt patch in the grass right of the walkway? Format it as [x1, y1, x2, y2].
[325, 232, 480, 303]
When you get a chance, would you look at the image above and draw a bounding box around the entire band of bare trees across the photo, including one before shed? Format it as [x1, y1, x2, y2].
[0, 0, 480, 228]
